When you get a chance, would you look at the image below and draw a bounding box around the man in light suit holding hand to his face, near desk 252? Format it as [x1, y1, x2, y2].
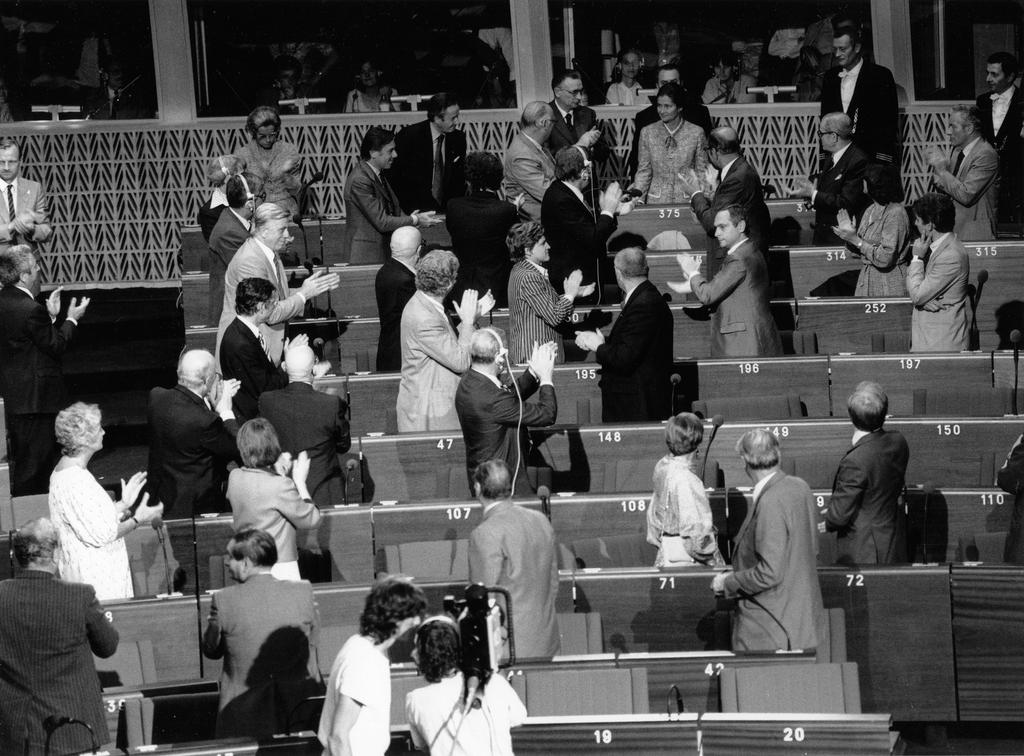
[906, 194, 971, 351]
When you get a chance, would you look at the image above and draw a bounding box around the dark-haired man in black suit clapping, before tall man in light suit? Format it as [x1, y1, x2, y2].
[220, 279, 290, 423]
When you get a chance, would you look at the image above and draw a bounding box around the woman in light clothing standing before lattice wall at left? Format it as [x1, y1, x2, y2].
[236, 106, 302, 217]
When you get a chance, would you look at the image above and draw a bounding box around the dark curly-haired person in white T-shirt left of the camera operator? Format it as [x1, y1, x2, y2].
[316, 578, 427, 756]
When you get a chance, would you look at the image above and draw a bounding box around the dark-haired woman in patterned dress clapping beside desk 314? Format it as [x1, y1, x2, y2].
[833, 163, 910, 297]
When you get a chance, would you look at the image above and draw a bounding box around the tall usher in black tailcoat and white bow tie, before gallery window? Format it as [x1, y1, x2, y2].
[821, 19, 900, 168]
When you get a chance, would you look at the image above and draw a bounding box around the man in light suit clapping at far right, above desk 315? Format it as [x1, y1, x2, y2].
[925, 106, 999, 242]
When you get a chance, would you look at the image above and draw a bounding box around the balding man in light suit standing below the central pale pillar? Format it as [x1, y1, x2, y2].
[502, 101, 555, 220]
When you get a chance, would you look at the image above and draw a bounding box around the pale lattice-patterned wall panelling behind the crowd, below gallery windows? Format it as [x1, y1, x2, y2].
[19, 109, 945, 285]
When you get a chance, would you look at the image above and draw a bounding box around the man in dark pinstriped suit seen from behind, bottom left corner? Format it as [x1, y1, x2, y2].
[0, 518, 119, 754]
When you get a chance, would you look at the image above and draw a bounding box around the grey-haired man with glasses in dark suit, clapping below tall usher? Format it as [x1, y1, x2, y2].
[791, 113, 869, 242]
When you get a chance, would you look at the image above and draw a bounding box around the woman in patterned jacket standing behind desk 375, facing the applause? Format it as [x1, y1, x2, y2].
[628, 83, 708, 204]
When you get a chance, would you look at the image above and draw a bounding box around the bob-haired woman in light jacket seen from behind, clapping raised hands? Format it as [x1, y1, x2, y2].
[227, 417, 321, 580]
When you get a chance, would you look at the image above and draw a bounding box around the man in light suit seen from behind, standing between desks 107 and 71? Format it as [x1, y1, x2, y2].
[469, 459, 561, 660]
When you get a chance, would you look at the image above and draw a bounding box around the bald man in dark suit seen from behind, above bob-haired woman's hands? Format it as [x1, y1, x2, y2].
[259, 344, 350, 507]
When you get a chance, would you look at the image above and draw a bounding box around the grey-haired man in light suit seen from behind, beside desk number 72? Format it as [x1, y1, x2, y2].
[711, 428, 824, 652]
